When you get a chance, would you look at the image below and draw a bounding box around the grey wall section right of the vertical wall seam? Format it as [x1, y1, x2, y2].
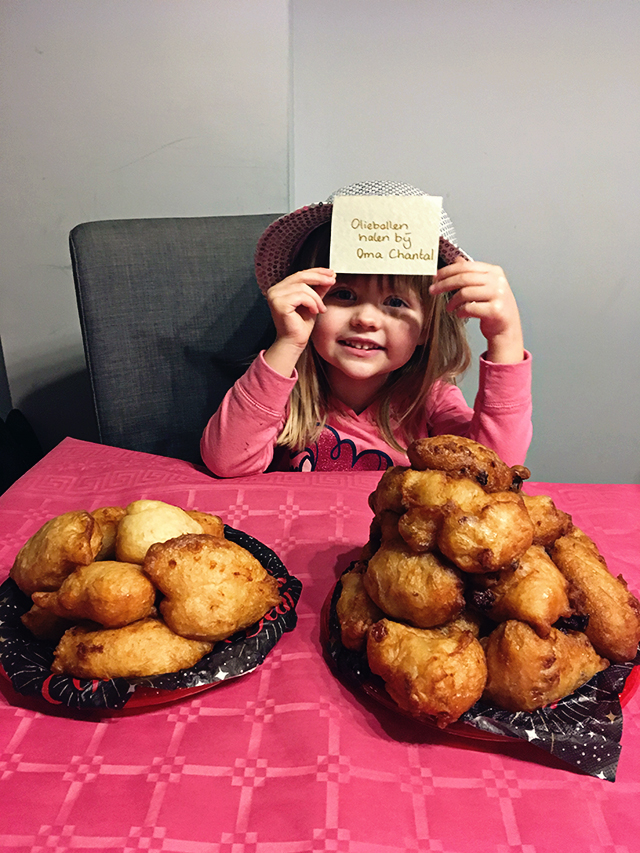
[293, 0, 640, 482]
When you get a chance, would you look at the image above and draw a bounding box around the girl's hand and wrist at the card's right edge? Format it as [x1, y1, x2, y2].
[429, 259, 524, 364]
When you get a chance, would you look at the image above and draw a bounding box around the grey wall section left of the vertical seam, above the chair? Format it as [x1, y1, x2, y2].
[0, 0, 289, 448]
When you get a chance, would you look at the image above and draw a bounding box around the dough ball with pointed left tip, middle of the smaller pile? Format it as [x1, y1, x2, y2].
[32, 560, 156, 628]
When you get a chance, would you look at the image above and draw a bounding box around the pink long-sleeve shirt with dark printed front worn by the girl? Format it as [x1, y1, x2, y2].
[200, 353, 532, 477]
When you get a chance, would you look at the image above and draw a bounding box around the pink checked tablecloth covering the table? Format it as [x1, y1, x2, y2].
[0, 439, 640, 853]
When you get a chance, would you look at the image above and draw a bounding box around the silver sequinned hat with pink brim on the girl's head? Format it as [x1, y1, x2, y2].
[255, 181, 468, 293]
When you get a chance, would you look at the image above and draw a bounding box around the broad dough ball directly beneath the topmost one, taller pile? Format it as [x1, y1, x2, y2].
[438, 492, 533, 573]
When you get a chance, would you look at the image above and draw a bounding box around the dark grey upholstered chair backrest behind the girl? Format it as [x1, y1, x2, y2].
[69, 214, 278, 462]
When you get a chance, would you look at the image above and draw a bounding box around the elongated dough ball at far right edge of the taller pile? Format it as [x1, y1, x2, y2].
[551, 530, 640, 663]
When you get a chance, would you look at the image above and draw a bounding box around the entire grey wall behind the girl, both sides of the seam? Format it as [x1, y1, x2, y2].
[0, 0, 640, 482]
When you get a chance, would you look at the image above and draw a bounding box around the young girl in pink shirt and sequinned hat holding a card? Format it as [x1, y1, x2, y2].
[201, 182, 531, 477]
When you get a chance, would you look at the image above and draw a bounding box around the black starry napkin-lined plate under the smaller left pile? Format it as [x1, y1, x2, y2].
[0, 525, 302, 711]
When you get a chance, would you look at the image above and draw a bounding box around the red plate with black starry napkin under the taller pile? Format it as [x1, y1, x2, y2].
[322, 581, 640, 782]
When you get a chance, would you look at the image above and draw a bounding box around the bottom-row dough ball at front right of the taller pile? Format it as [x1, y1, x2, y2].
[482, 619, 609, 711]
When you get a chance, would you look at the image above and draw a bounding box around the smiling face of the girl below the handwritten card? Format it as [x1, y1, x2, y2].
[311, 275, 425, 411]
